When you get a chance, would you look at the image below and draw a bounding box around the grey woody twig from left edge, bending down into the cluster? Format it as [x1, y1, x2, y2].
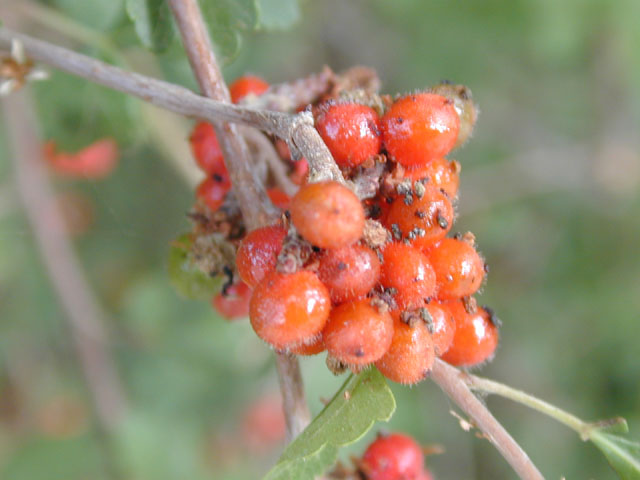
[0, 25, 344, 188]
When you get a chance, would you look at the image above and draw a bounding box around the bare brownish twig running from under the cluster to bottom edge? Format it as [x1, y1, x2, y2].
[431, 359, 544, 480]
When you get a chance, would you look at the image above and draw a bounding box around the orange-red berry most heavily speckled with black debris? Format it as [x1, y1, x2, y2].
[385, 186, 454, 250]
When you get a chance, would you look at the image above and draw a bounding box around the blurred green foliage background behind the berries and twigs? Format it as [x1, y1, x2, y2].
[0, 0, 640, 480]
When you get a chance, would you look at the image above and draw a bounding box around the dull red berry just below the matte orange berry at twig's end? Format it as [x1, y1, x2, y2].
[318, 245, 380, 303]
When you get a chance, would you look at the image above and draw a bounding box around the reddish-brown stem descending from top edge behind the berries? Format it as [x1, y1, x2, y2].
[169, 0, 312, 440]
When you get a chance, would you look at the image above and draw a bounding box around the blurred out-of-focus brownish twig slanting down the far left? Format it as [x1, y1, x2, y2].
[3, 90, 126, 430]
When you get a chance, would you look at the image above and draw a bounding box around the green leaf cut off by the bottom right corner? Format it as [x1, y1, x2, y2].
[589, 429, 640, 480]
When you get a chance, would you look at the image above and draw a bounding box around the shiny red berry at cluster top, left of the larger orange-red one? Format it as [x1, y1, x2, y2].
[316, 103, 381, 168]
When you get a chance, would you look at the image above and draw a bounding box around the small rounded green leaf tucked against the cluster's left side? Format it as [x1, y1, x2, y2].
[167, 234, 224, 300]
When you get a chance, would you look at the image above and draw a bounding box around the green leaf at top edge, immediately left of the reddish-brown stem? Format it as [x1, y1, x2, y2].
[127, 0, 174, 52]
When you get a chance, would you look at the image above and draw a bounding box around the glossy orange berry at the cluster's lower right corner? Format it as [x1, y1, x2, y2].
[442, 300, 498, 367]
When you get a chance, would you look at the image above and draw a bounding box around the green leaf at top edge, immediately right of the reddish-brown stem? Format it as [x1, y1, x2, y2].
[200, 0, 258, 63]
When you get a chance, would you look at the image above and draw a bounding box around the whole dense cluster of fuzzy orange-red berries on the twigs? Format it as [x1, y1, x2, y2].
[185, 72, 498, 382]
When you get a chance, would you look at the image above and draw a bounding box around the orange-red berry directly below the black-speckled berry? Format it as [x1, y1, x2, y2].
[380, 243, 436, 310]
